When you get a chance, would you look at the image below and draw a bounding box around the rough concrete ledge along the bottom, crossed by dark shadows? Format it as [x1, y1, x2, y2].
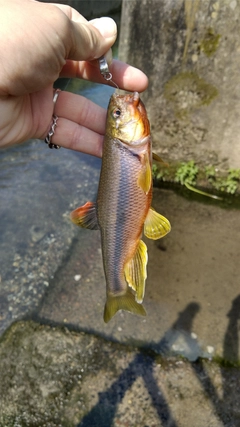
[0, 322, 240, 427]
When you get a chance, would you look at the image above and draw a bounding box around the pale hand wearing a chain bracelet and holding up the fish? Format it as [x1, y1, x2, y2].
[0, 0, 148, 157]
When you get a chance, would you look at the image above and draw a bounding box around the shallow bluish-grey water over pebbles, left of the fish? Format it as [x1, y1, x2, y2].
[0, 82, 112, 334]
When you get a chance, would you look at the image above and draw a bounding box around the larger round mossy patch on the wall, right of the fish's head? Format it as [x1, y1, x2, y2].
[164, 71, 218, 116]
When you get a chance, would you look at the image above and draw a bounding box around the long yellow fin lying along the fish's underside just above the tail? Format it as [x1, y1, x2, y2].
[124, 240, 148, 303]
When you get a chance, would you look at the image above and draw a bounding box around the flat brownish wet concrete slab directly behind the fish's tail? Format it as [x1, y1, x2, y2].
[33, 189, 240, 361]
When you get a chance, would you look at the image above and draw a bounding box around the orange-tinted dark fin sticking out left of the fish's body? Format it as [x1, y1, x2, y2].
[70, 202, 99, 230]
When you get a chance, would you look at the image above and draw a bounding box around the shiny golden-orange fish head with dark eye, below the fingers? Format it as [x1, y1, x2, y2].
[106, 92, 150, 146]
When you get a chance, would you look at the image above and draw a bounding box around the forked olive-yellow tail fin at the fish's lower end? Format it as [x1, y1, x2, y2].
[103, 289, 146, 323]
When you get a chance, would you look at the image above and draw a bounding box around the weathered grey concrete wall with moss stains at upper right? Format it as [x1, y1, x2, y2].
[119, 0, 240, 169]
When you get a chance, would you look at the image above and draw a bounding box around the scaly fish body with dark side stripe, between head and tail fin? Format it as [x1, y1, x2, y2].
[97, 140, 152, 296]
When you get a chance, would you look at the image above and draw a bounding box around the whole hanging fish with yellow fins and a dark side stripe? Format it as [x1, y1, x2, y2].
[71, 92, 171, 323]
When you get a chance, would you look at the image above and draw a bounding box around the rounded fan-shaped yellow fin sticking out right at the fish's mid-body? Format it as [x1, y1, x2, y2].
[144, 208, 171, 240]
